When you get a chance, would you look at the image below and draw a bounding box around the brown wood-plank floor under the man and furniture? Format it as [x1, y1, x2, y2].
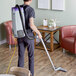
[0, 45, 76, 76]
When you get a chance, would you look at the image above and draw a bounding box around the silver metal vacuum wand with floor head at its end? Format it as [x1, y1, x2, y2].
[37, 37, 67, 72]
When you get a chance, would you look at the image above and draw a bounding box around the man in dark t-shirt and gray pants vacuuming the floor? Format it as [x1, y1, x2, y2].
[18, 0, 42, 76]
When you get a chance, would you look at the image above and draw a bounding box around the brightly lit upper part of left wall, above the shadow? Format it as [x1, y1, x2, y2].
[0, 0, 15, 23]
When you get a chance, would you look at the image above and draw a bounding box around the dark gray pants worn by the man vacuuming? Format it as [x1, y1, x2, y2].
[18, 37, 34, 76]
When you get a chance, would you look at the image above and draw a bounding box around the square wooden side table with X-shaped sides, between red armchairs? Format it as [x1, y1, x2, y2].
[35, 25, 59, 51]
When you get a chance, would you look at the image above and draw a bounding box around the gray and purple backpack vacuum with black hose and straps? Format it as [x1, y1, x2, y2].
[12, 5, 34, 39]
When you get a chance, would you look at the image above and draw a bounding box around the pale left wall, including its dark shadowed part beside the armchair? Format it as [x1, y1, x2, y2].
[0, 0, 16, 44]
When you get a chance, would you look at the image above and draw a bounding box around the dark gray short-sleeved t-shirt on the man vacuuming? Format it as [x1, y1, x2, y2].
[21, 5, 35, 30]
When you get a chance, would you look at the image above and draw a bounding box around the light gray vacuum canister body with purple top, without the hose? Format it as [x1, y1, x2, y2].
[12, 7, 25, 38]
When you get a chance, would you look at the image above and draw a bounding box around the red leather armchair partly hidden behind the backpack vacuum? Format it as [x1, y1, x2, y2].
[4, 20, 17, 45]
